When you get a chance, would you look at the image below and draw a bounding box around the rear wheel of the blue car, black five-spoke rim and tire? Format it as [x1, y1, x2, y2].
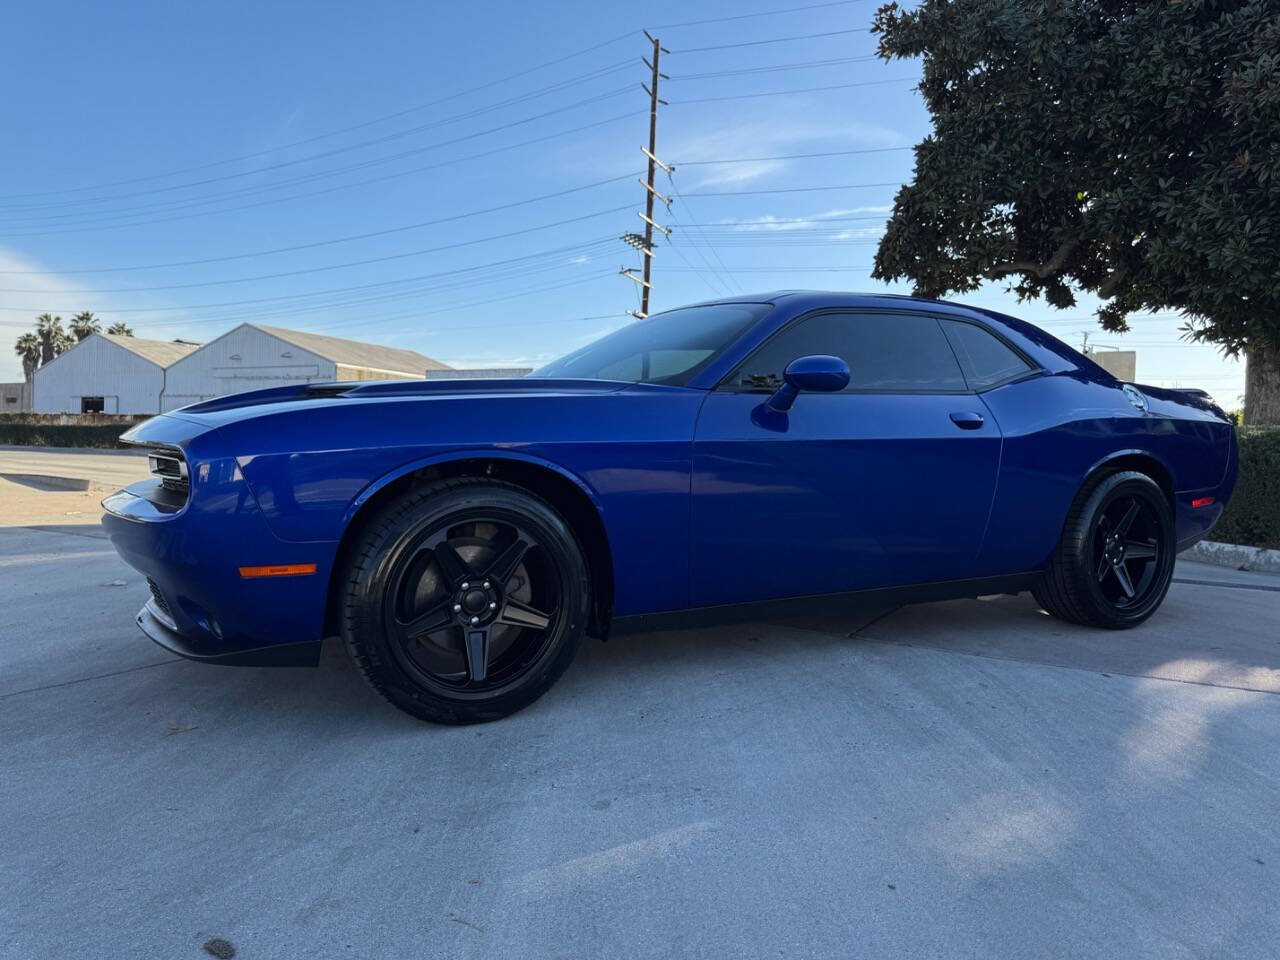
[1032, 470, 1176, 630]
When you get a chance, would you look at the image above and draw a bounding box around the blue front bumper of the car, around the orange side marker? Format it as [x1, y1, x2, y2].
[102, 461, 337, 666]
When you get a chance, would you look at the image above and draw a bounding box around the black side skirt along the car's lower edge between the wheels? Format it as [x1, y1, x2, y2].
[609, 571, 1041, 635]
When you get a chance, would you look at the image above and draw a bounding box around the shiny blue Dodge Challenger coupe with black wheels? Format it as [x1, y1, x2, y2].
[102, 292, 1236, 723]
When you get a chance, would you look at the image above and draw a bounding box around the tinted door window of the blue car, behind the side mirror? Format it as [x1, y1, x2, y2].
[732, 314, 965, 392]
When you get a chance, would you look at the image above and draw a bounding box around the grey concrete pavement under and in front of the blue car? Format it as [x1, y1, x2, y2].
[0, 524, 1280, 960]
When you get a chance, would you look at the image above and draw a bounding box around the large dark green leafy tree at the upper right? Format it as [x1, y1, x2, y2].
[873, 0, 1280, 424]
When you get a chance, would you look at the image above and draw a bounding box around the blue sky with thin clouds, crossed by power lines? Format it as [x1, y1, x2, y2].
[0, 0, 1244, 407]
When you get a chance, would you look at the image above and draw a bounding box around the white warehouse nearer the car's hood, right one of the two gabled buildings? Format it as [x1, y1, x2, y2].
[160, 324, 449, 412]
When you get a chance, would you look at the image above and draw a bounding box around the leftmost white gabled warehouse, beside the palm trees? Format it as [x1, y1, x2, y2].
[31, 333, 200, 413]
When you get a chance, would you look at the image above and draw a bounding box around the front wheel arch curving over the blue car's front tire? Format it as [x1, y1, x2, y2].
[325, 451, 613, 637]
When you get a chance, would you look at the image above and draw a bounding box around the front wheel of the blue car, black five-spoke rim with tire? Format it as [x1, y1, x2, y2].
[339, 479, 590, 724]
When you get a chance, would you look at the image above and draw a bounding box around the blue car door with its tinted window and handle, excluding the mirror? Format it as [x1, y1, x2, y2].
[690, 311, 1025, 607]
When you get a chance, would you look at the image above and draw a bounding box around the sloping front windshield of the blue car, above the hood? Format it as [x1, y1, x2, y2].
[530, 303, 771, 387]
